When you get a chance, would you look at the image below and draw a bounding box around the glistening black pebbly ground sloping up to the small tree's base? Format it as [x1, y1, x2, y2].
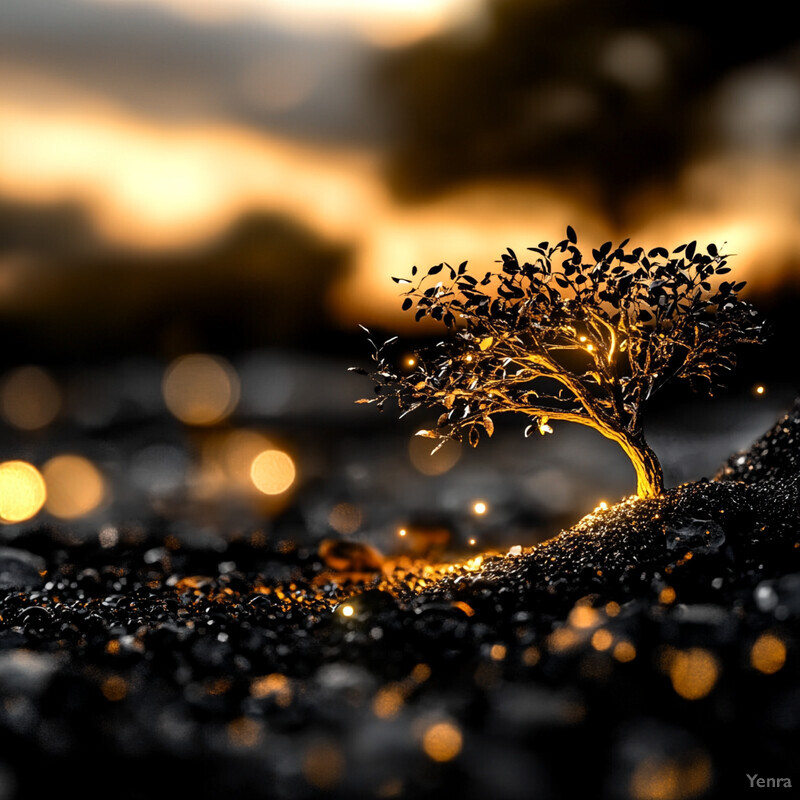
[0, 405, 800, 800]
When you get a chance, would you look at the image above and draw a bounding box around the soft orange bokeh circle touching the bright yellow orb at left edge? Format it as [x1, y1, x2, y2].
[42, 454, 106, 519]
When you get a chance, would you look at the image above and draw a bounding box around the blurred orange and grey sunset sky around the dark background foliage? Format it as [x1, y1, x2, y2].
[0, 0, 800, 336]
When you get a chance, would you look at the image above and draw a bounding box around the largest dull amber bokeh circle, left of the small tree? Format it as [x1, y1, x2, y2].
[162, 353, 240, 425]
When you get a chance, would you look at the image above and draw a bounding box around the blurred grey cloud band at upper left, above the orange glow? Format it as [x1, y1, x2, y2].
[0, 0, 384, 144]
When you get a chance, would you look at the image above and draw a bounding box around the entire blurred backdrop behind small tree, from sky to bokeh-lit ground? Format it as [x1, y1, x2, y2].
[0, 0, 800, 549]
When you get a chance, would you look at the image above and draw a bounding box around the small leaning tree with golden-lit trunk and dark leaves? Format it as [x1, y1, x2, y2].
[354, 227, 763, 497]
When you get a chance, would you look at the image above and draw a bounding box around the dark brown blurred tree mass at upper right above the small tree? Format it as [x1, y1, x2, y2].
[381, 0, 797, 223]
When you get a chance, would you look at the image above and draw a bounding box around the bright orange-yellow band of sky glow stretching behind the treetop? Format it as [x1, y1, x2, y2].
[0, 79, 800, 340]
